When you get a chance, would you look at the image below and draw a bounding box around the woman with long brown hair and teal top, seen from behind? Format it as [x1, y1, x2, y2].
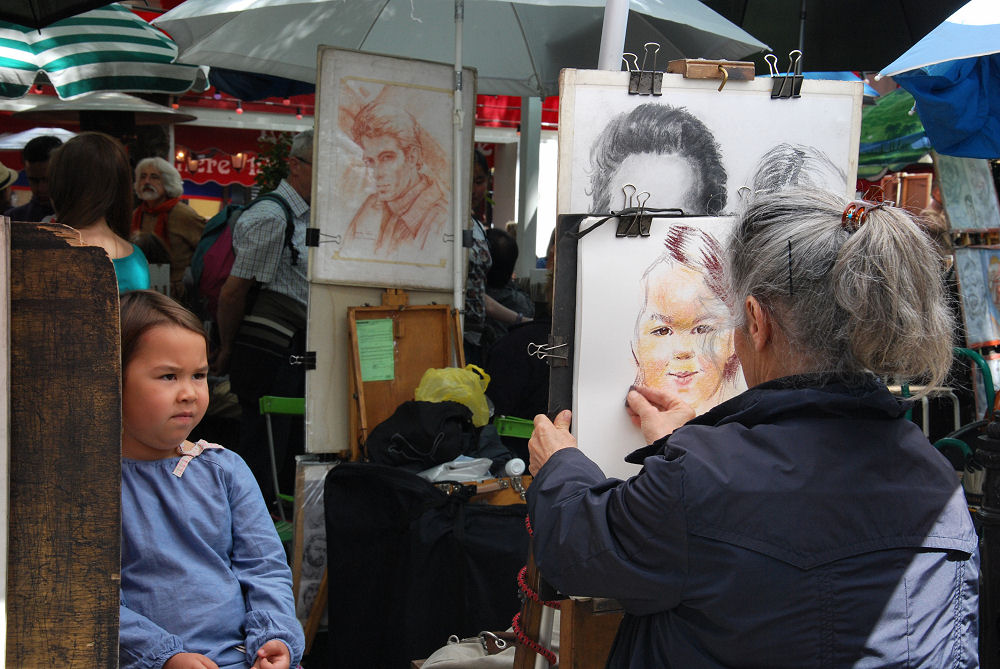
[48, 132, 150, 293]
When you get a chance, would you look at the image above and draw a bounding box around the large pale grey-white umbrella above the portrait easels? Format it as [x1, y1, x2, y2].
[153, 0, 767, 96]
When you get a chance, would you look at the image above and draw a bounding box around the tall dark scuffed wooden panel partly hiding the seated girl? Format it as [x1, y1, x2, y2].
[6, 223, 121, 667]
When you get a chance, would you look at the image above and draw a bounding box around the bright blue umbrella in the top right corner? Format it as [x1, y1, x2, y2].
[878, 0, 1000, 158]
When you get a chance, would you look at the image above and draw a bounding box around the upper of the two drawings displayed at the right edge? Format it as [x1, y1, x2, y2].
[934, 154, 1000, 231]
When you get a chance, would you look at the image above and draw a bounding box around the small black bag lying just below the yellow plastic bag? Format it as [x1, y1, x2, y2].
[365, 401, 475, 472]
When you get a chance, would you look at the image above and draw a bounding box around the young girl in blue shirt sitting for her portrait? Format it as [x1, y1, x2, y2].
[118, 291, 305, 669]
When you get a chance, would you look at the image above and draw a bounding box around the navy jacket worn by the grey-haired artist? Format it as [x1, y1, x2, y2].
[528, 377, 979, 669]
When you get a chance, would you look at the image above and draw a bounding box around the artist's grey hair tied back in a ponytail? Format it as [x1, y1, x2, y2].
[727, 187, 954, 394]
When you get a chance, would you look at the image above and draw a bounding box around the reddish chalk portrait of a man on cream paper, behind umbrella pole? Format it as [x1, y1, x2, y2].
[309, 47, 475, 290]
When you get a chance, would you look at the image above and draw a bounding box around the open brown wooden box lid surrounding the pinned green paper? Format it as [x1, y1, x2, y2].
[347, 304, 465, 460]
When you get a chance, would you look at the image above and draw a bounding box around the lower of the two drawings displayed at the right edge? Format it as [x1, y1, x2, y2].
[955, 246, 1000, 348]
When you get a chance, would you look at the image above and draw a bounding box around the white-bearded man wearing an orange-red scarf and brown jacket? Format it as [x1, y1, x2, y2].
[132, 156, 205, 300]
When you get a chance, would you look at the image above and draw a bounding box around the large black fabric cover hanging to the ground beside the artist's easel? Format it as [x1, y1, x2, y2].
[324, 463, 528, 669]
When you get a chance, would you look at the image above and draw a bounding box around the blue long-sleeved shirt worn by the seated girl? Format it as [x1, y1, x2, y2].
[119, 442, 305, 669]
